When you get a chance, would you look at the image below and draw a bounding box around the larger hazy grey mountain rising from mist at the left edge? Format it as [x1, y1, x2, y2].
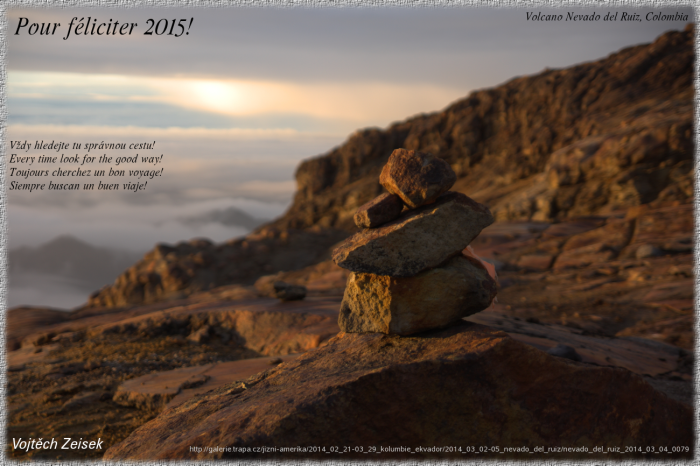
[9, 235, 141, 289]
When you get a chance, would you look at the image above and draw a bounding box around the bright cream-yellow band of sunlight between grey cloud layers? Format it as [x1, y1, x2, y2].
[7, 71, 466, 127]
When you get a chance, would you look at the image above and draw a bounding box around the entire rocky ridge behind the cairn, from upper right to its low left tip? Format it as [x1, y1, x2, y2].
[88, 26, 694, 306]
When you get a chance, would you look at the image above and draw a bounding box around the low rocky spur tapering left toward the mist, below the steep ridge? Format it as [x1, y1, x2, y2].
[87, 227, 346, 307]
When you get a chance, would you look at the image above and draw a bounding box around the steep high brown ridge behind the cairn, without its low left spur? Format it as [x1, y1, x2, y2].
[273, 25, 694, 231]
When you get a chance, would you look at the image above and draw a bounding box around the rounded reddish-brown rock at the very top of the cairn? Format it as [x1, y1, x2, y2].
[379, 149, 457, 208]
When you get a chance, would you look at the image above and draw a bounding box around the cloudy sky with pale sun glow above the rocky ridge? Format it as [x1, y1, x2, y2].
[5, 7, 693, 310]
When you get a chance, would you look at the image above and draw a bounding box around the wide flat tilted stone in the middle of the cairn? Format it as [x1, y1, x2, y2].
[333, 193, 493, 277]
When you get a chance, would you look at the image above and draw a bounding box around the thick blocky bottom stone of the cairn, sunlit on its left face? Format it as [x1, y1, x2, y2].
[338, 256, 496, 335]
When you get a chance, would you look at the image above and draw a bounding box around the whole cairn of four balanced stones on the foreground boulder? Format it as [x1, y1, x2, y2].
[333, 149, 497, 335]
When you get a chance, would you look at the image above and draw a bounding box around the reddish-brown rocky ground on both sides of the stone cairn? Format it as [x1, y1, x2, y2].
[7, 204, 694, 459]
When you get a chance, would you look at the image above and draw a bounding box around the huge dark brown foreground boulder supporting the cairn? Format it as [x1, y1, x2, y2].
[104, 322, 694, 461]
